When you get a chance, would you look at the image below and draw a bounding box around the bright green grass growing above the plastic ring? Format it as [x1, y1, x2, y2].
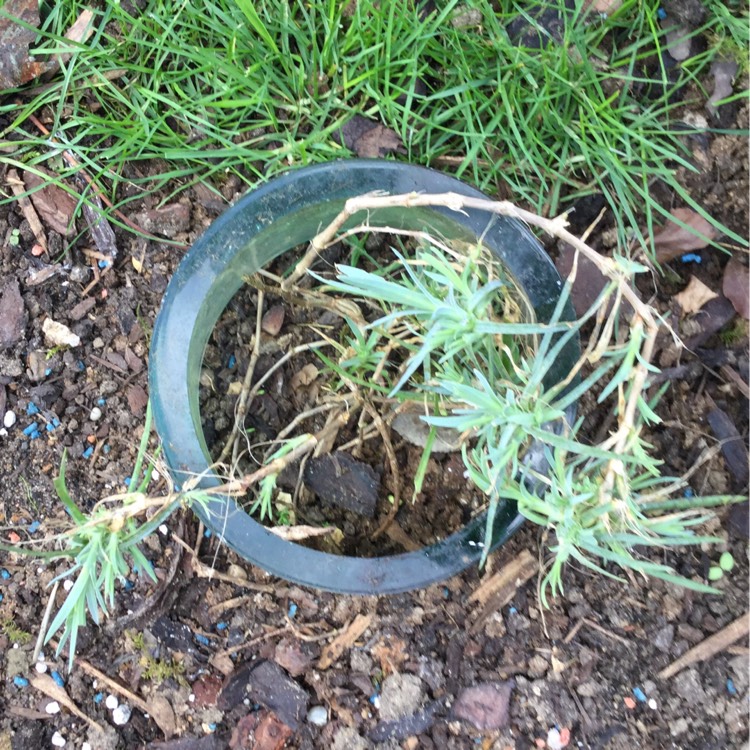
[0, 0, 747, 250]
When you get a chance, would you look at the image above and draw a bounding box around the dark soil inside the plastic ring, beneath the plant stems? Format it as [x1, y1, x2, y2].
[200, 236, 494, 557]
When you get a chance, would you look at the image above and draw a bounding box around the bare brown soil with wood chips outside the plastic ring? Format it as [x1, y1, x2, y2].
[0, 32, 749, 750]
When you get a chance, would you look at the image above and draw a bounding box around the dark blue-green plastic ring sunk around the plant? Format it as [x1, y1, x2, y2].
[149, 160, 579, 594]
